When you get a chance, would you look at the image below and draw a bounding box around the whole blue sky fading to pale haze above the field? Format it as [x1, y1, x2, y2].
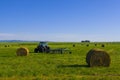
[0, 0, 120, 42]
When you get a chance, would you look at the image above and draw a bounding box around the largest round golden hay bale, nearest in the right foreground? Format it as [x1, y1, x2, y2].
[86, 49, 111, 67]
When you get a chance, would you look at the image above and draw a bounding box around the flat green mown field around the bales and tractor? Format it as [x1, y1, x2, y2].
[0, 42, 120, 80]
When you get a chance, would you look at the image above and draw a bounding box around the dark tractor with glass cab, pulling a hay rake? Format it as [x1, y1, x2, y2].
[34, 42, 50, 53]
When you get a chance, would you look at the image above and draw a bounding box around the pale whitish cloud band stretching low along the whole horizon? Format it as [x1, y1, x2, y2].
[0, 33, 120, 42]
